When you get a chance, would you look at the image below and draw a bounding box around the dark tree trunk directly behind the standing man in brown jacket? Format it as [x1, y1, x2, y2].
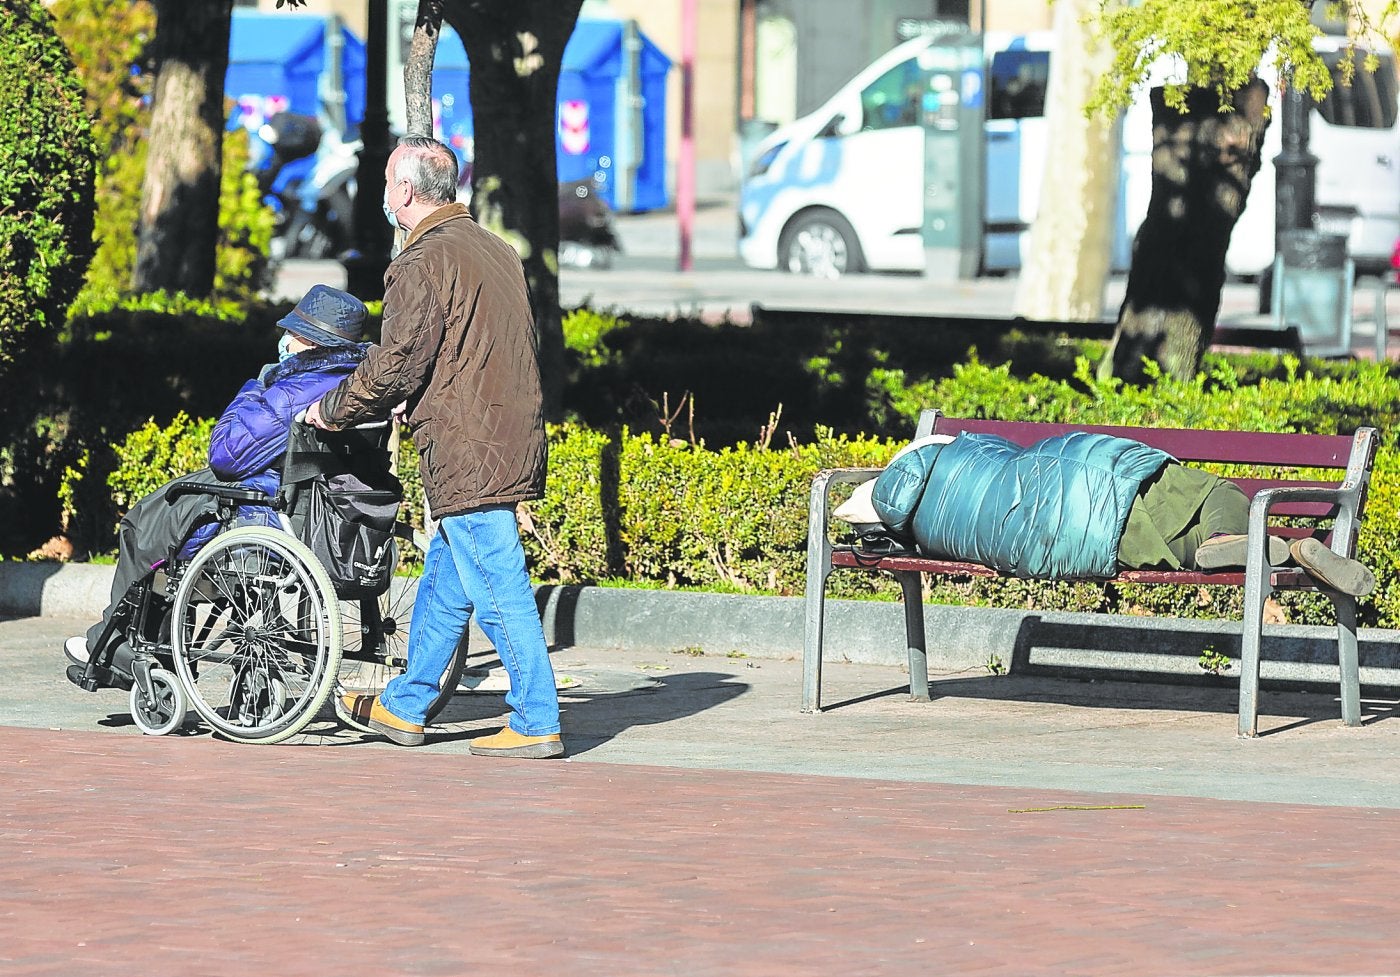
[445, 0, 582, 420]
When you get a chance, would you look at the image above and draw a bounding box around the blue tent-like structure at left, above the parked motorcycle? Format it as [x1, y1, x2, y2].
[224, 10, 365, 129]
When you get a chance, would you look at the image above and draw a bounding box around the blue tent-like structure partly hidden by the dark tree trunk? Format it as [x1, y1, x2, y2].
[433, 20, 671, 210]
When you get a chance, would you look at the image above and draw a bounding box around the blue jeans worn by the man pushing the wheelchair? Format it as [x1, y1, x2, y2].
[379, 505, 559, 736]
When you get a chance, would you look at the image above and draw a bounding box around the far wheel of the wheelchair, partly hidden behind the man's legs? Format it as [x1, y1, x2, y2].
[336, 529, 466, 722]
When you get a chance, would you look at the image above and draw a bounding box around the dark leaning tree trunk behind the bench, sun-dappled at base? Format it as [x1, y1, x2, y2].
[1099, 78, 1268, 384]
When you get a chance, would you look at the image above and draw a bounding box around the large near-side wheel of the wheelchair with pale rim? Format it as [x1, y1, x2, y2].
[171, 526, 340, 743]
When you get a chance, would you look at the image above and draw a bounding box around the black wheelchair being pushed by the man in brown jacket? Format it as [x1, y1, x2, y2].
[69, 423, 465, 743]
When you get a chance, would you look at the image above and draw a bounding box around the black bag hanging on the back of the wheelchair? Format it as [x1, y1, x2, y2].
[281, 424, 403, 599]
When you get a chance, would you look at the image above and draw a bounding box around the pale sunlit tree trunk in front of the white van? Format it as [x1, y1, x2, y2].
[1015, 0, 1121, 322]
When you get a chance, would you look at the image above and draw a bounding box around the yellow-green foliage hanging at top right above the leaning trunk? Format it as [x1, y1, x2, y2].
[1089, 0, 1400, 112]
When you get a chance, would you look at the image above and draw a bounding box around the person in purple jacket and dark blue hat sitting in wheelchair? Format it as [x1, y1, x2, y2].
[63, 286, 368, 675]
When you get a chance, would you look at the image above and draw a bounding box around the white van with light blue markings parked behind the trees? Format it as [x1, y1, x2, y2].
[739, 32, 1400, 277]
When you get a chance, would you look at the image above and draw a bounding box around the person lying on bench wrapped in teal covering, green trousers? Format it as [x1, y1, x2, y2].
[837, 431, 1375, 596]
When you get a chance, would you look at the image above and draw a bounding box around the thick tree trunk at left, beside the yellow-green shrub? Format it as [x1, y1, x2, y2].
[132, 0, 232, 295]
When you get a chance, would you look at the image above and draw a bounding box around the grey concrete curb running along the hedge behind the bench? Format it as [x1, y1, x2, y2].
[0, 563, 1400, 687]
